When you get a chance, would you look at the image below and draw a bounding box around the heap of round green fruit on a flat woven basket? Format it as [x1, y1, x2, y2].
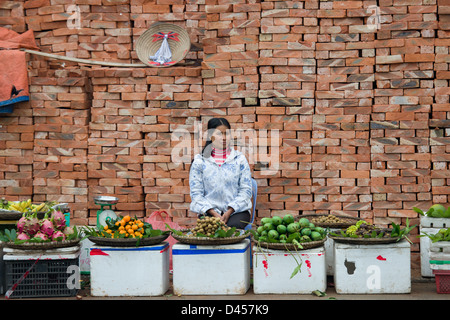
[254, 214, 326, 243]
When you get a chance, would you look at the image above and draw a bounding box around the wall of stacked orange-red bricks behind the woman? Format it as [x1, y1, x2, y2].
[0, 0, 450, 263]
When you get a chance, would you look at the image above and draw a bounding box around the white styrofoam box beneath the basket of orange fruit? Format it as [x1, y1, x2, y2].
[90, 242, 169, 297]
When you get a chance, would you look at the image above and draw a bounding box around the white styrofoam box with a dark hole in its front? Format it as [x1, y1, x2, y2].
[334, 240, 411, 294]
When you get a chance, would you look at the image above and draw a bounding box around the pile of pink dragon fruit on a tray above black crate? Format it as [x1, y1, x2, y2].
[0, 210, 78, 244]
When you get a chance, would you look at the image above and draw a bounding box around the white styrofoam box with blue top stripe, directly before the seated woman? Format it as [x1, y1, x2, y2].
[172, 239, 250, 295]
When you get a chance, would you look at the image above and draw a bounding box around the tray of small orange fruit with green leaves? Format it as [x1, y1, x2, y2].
[85, 215, 168, 239]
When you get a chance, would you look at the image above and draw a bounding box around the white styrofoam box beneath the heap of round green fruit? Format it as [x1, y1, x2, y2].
[253, 246, 327, 294]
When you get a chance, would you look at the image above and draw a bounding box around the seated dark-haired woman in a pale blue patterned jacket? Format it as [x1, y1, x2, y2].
[189, 118, 252, 229]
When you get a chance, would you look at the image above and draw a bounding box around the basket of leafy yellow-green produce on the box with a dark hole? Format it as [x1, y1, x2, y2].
[330, 219, 416, 240]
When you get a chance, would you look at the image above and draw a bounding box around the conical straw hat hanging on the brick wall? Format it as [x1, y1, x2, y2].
[136, 22, 191, 67]
